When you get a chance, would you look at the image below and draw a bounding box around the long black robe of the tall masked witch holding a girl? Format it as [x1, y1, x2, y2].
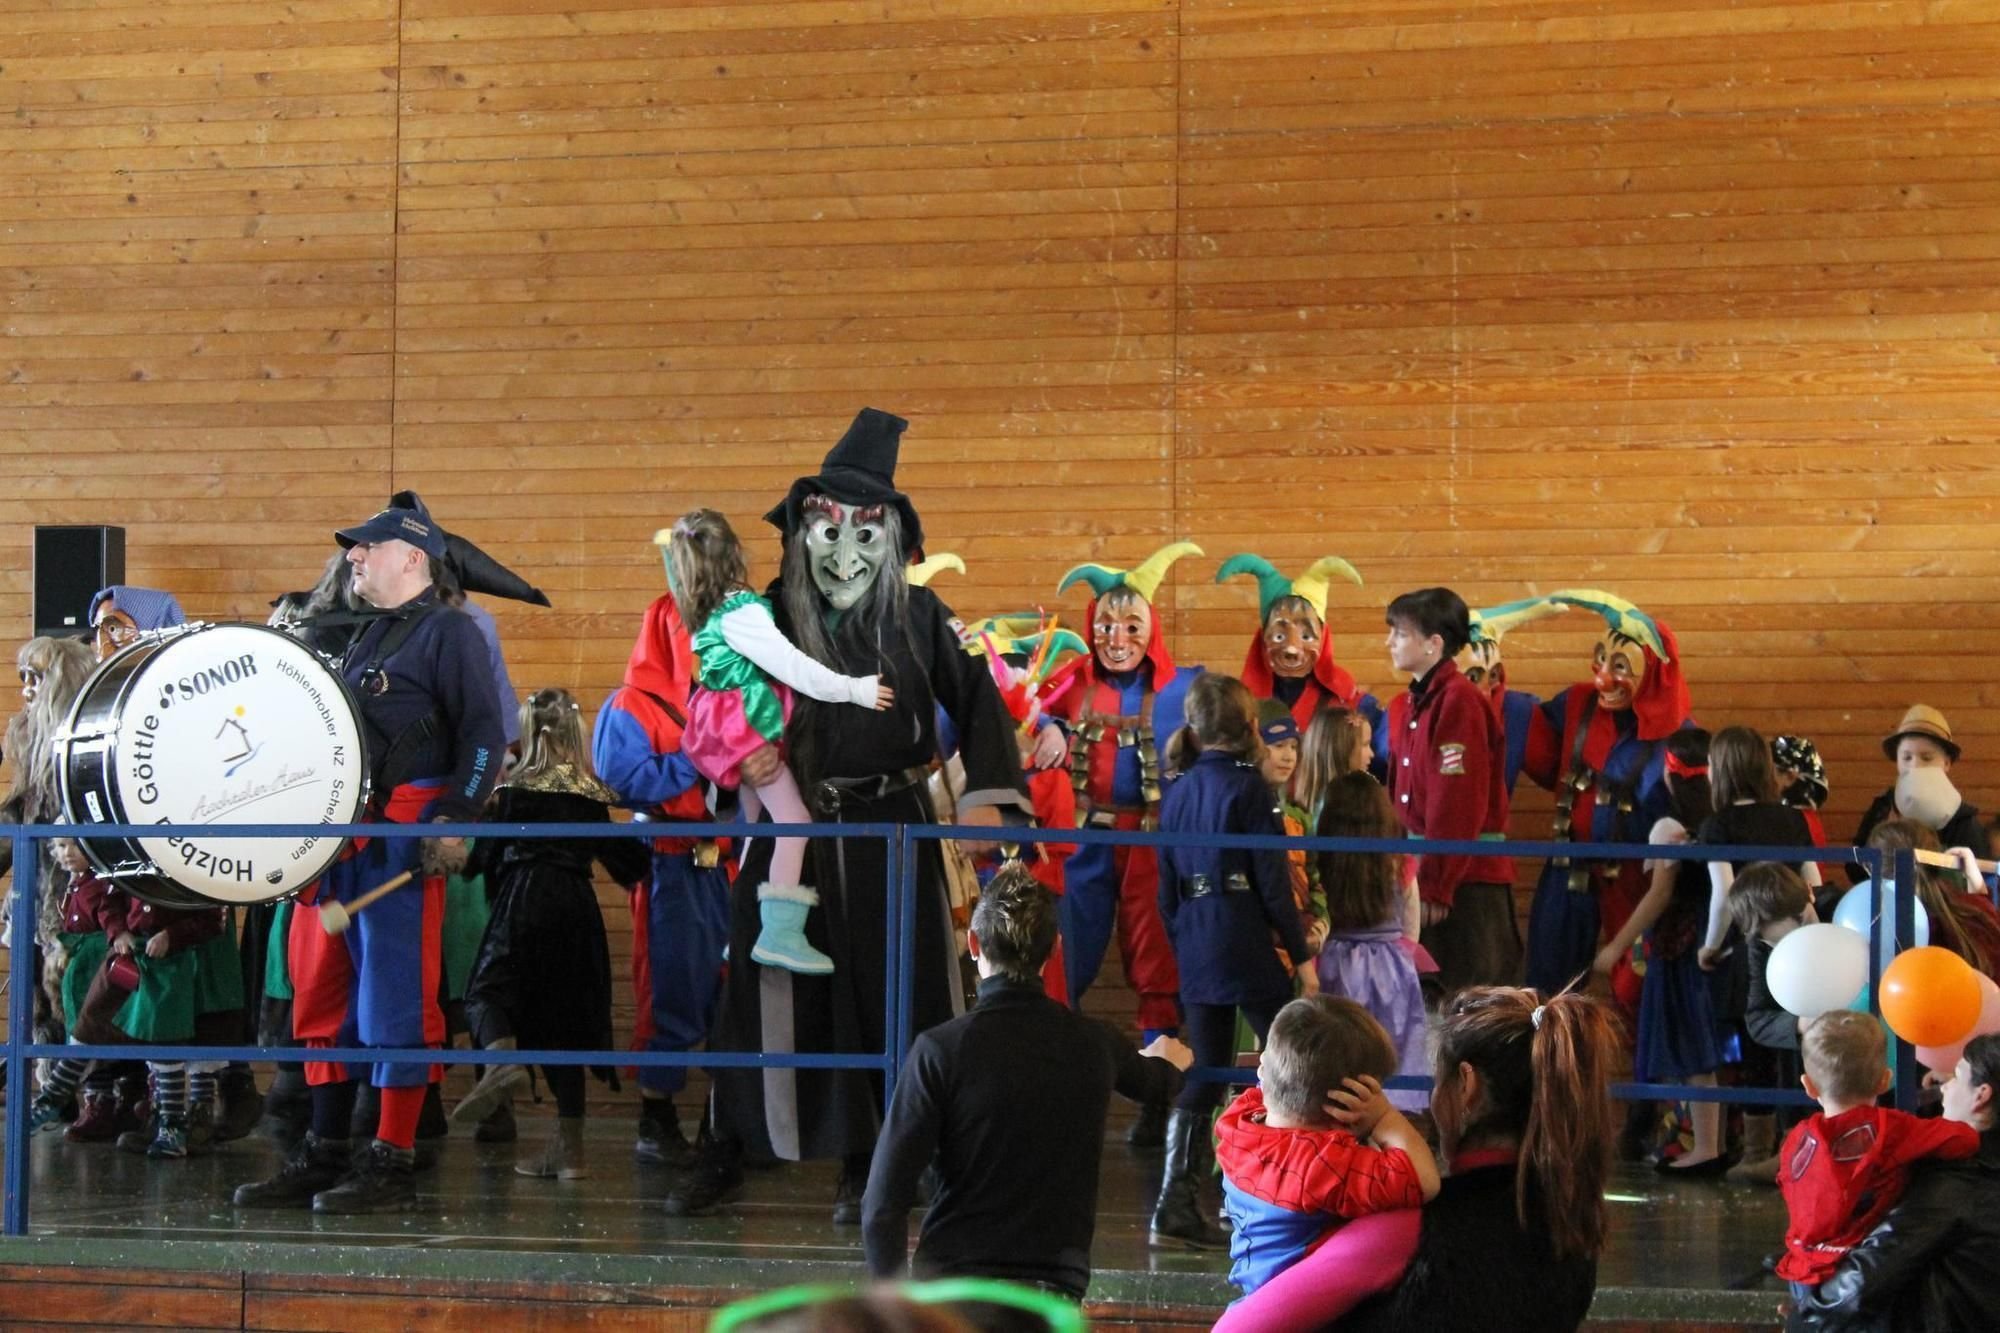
[710, 586, 1034, 1161]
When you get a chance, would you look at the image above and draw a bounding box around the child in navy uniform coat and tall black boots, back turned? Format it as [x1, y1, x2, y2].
[1150, 675, 1312, 1249]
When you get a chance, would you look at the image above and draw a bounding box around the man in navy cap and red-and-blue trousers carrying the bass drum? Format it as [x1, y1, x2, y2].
[236, 492, 506, 1213]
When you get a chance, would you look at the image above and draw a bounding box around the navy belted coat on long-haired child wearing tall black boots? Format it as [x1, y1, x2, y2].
[1160, 751, 1312, 1005]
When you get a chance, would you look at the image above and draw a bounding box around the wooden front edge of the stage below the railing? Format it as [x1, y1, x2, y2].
[0, 1235, 1778, 1333]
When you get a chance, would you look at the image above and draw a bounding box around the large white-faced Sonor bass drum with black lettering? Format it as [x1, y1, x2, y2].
[56, 624, 368, 907]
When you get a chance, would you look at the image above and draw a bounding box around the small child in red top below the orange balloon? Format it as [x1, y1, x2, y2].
[1778, 1009, 1980, 1295]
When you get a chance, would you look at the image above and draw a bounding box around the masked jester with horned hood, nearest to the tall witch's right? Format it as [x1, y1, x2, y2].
[1046, 542, 1202, 1033]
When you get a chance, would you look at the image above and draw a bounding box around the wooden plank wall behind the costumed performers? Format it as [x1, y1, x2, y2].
[0, 0, 2000, 1040]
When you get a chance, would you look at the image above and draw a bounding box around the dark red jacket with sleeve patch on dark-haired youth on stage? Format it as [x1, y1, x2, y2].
[1388, 658, 1514, 907]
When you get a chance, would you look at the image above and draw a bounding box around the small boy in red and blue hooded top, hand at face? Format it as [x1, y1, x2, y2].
[1216, 995, 1440, 1295]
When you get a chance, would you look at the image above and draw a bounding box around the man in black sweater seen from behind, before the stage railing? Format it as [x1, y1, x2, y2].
[862, 863, 1194, 1301]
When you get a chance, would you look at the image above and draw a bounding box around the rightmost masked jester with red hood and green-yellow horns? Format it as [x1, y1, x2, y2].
[1522, 588, 1692, 1003]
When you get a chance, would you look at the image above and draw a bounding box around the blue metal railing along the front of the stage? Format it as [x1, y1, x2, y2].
[0, 823, 1918, 1235]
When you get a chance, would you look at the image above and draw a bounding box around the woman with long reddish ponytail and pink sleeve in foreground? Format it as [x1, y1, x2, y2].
[1216, 987, 1618, 1333]
